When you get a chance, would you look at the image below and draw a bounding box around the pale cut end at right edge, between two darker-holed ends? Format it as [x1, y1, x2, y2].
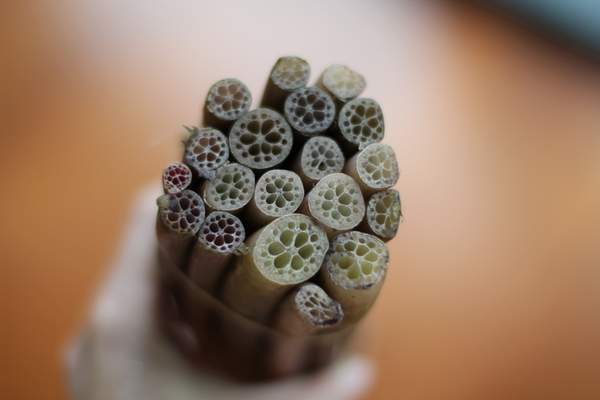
[356, 143, 400, 189]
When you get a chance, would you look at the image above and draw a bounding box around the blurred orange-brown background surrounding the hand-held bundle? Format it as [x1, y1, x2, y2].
[0, 1, 600, 400]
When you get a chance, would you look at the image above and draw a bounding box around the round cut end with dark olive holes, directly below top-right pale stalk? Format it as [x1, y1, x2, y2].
[338, 98, 385, 148]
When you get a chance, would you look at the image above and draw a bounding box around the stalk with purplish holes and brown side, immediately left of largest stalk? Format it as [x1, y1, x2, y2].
[189, 211, 246, 293]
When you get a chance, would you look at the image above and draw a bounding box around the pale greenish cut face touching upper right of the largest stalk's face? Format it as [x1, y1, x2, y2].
[308, 173, 365, 231]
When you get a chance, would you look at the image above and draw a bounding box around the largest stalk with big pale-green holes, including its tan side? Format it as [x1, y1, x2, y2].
[223, 214, 329, 322]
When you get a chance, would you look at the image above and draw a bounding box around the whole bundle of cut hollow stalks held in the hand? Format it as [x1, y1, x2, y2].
[157, 57, 402, 380]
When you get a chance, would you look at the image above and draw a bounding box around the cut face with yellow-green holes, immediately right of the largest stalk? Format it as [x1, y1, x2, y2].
[325, 231, 389, 289]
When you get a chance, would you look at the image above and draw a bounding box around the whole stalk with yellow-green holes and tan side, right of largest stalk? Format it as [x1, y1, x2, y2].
[320, 231, 389, 323]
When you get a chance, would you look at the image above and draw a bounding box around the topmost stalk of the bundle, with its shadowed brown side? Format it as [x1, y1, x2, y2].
[261, 56, 310, 111]
